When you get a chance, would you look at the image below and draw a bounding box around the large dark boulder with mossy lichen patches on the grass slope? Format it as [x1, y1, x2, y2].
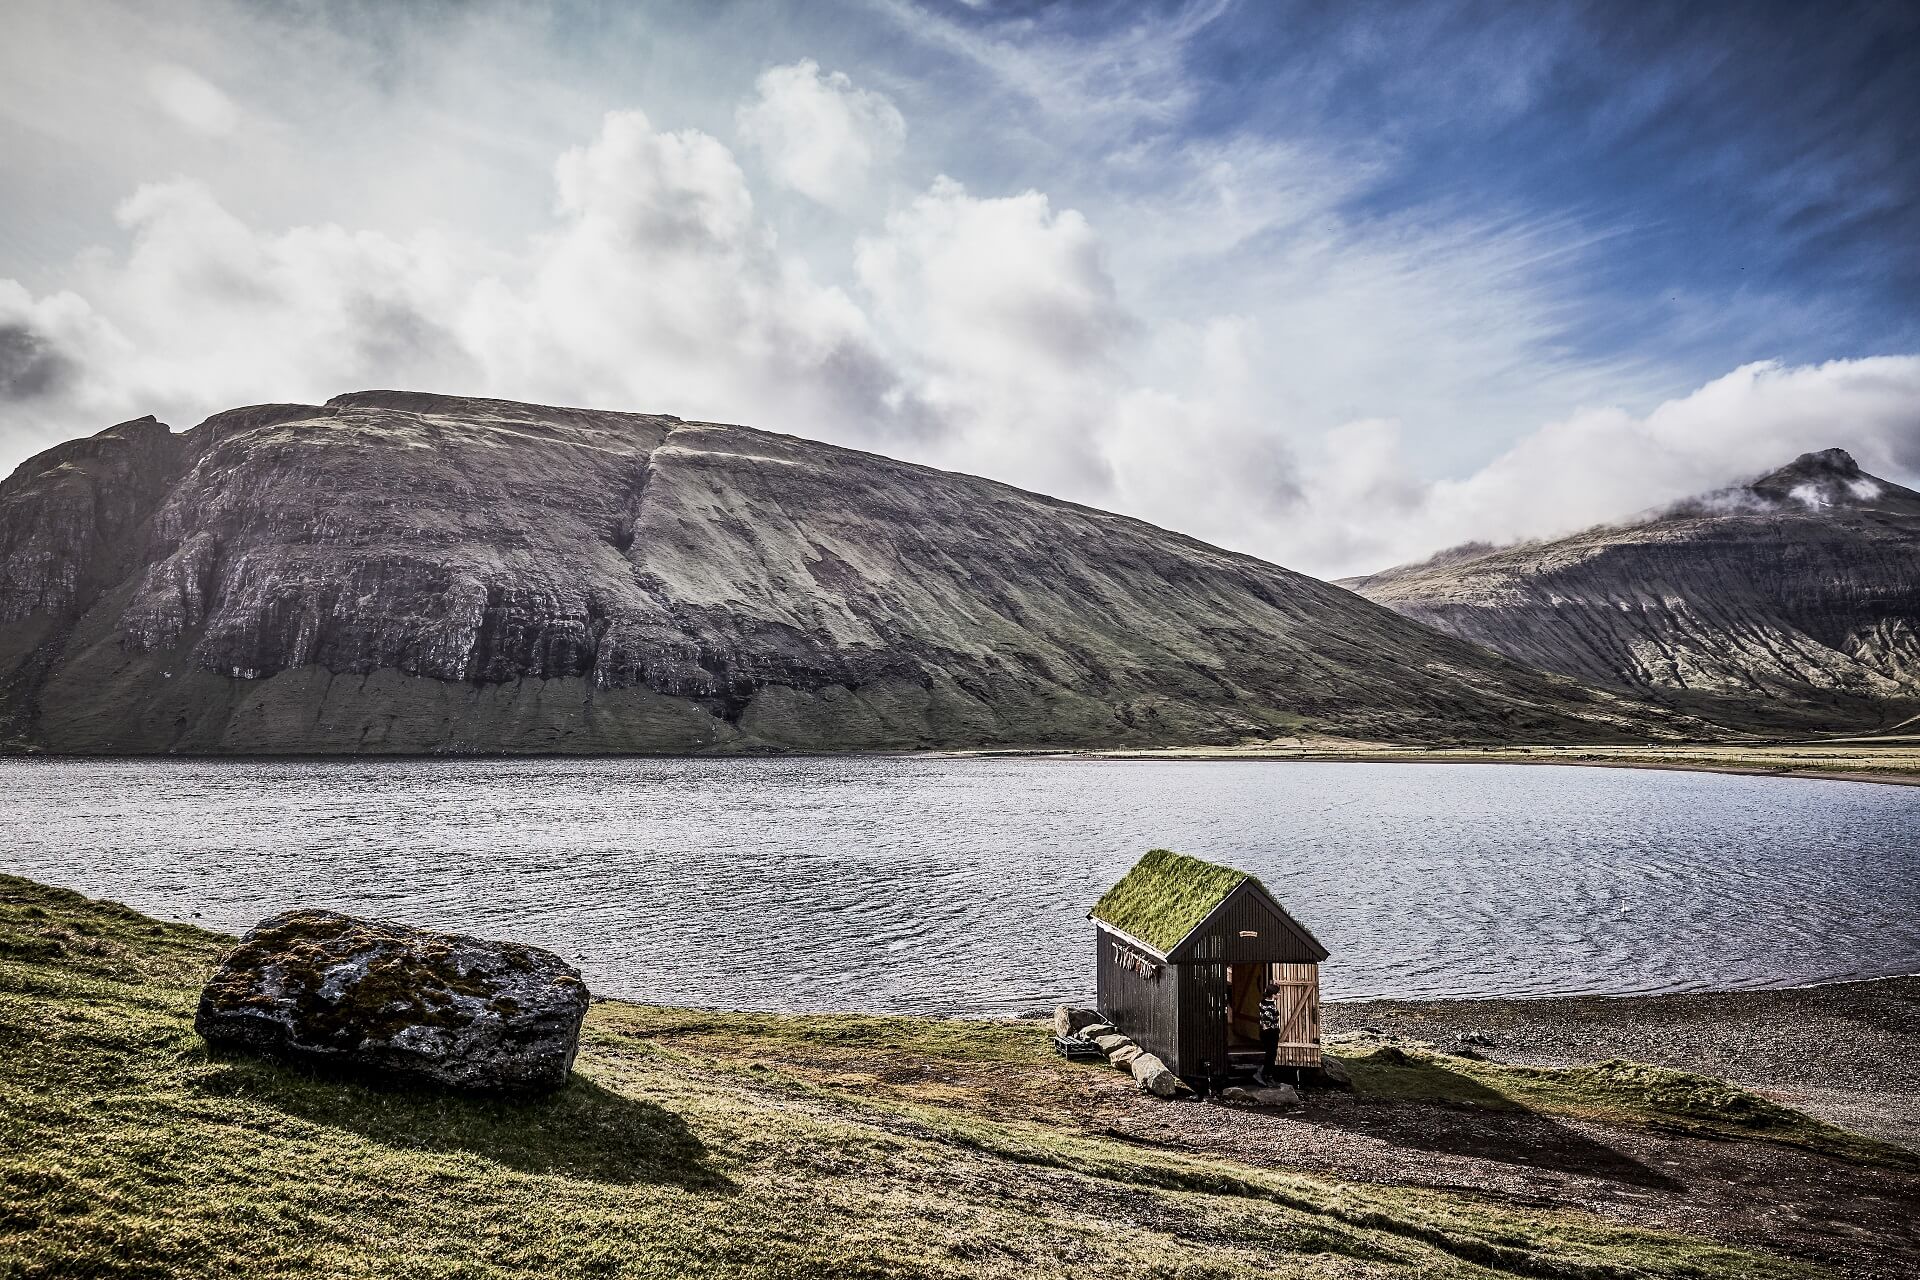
[194, 910, 588, 1090]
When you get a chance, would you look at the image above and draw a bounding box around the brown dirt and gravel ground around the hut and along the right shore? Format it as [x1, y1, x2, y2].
[614, 979, 1920, 1280]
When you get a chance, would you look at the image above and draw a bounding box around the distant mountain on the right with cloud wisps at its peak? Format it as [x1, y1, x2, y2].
[1342, 449, 1920, 733]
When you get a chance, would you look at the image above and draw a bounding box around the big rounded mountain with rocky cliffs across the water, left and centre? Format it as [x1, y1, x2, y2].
[0, 391, 1674, 752]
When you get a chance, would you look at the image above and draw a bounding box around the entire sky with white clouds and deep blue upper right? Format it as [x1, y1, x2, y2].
[0, 0, 1920, 578]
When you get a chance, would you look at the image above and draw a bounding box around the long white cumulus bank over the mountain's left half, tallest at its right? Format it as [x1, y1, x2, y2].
[0, 111, 916, 454]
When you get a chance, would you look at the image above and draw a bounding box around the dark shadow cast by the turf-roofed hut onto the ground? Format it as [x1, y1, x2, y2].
[1304, 1063, 1686, 1192]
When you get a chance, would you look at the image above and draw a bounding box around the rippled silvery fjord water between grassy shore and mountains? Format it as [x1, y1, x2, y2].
[0, 758, 1920, 1013]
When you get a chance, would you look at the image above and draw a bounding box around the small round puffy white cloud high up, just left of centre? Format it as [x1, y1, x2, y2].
[735, 58, 906, 211]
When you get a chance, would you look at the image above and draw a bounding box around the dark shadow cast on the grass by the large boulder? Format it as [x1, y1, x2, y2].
[196, 1055, 733, 1194]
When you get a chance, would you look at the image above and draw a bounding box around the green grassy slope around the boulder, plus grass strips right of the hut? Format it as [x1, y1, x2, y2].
[0, 877, 1866, 1280]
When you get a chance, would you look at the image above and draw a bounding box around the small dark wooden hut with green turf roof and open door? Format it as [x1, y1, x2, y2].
[1089, 848, 1327, 1080]
